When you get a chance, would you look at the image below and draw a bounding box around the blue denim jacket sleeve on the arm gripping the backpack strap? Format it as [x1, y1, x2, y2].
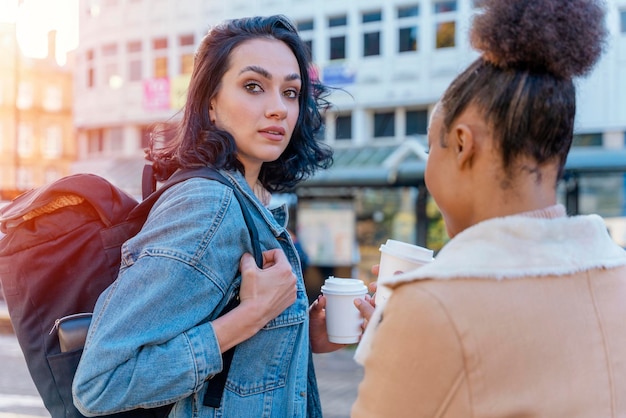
[73, 179, 249, 415]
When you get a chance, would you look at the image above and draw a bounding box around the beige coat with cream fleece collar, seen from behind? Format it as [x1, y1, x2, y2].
[352, 209, 626, 418]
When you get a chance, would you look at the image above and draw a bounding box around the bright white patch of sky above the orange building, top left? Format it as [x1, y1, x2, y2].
[0, 0, 78, 65]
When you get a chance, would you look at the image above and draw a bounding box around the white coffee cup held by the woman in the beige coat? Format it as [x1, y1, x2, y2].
[376, 239, 433, 306]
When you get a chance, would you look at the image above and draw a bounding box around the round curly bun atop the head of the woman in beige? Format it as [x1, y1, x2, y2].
[470, 0, 607, 78]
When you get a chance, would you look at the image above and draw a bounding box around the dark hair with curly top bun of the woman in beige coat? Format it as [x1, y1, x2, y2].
[440, 0, 607, 183]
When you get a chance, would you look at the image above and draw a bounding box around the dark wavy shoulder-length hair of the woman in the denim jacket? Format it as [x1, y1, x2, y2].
[147, 15, 332, 192]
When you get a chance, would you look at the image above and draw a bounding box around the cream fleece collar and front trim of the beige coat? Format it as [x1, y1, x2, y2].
[355, 215, 626, 364]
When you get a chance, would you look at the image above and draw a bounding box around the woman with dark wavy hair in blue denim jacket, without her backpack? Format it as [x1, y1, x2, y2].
[73, 16, 338, 418]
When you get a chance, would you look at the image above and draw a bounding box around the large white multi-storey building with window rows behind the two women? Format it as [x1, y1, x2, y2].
[73, 0, 626, 280]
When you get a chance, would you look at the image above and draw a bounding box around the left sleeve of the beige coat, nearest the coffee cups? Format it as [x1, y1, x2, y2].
[352, 283, 471, 418]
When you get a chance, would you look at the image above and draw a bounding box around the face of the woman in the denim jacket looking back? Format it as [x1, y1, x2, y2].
[209, 38, 302, 177]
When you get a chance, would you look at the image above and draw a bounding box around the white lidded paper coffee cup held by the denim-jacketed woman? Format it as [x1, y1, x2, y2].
[322, 276, 367, 344]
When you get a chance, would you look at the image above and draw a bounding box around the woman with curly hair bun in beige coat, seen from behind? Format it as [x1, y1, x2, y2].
[352, 0, 626, 418]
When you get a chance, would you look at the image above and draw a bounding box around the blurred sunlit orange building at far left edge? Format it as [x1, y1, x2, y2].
[0, 24, 77, 199]
